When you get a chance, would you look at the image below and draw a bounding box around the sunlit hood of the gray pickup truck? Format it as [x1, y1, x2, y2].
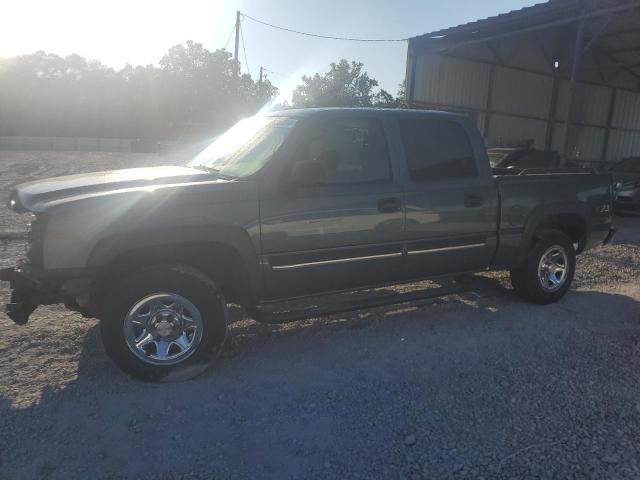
[9, 166, 215, 212]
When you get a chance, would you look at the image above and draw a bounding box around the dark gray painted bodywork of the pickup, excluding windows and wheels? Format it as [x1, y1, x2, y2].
[3, 109, 612, 314]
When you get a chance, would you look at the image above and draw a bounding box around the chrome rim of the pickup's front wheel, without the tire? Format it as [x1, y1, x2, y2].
[123, 293, 203, 365]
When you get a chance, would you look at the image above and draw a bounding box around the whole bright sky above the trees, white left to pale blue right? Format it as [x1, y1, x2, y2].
[0, 0, 538, 94]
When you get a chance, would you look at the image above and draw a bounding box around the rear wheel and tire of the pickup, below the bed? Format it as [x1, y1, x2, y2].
[510, 230, 576, 304]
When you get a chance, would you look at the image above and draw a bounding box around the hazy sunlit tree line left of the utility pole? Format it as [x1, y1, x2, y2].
[0, 41, 277, 138]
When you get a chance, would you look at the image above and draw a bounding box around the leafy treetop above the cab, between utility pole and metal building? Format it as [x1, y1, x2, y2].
[292, 58, 401, 108]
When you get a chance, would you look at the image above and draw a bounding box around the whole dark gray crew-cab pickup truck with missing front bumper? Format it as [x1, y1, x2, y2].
[0, 108, 613, 380]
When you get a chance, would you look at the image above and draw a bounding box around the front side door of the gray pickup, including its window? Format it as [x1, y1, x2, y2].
[260, 114, 403, 299]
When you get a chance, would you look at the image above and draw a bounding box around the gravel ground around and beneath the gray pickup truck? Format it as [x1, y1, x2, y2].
[0, 152, 640, 479]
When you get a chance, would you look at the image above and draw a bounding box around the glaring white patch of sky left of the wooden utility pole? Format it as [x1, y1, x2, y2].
[0, 0, 234, 68]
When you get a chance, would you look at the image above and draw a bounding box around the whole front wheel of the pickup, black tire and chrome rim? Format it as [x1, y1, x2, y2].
[100, 264, 227, 381]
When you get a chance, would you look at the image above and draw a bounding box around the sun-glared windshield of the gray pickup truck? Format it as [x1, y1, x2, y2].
[189, 115, 296, 178]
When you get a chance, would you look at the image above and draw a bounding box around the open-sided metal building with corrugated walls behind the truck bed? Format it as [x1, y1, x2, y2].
[406, 0, 640, 167]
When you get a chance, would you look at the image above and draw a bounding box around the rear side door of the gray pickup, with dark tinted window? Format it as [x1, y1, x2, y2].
[397, 115, 498, 278]
